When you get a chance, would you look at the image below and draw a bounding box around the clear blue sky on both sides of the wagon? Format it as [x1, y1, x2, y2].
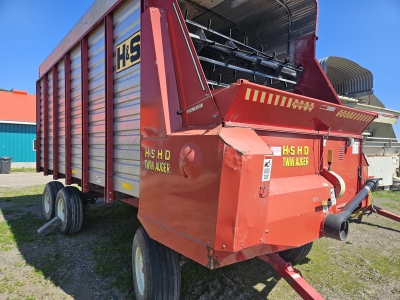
[0, 0, 400, 138]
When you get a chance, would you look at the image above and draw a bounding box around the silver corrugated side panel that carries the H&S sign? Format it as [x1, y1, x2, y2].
[113, 0, 140, 197]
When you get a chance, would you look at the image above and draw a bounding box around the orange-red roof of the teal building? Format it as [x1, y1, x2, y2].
[0, 90, 36, 123]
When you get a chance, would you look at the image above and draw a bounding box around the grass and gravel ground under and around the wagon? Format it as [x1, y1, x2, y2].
[0, 173, 400, 300]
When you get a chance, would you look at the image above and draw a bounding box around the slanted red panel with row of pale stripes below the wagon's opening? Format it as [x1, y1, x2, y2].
[214, 80, 377, 136]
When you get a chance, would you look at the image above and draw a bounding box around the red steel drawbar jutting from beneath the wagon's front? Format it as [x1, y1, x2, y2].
[258, 253, 324, 300]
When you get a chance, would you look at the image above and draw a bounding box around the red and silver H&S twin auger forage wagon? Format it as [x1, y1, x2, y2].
[37, 0, 396, 299]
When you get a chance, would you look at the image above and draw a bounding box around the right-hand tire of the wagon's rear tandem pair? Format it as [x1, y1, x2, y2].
[55, 186, 84, 234]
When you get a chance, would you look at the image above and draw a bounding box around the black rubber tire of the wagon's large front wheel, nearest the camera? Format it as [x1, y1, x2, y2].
[132, 227, 181, 300]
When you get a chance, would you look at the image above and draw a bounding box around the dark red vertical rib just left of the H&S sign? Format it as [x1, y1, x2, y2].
[104, 14, 115, 202]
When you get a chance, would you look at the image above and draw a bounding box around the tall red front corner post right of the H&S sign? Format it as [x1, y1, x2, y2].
[140, 8, 182, 138]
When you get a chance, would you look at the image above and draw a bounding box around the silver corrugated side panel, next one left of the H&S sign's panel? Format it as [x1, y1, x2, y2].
[88, 23, 106, 186]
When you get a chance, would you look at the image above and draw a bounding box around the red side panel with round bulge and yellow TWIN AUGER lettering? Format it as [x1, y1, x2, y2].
[138, 126, 222, 251]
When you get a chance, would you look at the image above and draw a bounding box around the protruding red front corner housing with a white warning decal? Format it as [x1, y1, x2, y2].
[214, 128, 272, 252]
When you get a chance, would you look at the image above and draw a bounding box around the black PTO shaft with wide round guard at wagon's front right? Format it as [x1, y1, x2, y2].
[324, 178, 380, 241]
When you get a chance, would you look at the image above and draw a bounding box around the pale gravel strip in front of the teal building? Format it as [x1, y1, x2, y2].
[0, 172, 65, 188]
